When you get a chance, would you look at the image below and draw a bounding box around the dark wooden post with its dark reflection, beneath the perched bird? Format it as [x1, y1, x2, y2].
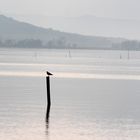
[46, 76, 51, 121]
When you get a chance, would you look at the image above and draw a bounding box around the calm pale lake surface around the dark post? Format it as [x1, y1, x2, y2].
[0, 49, 140, 140]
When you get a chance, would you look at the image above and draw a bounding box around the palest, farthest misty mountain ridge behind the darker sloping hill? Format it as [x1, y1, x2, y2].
[10, 15, 140, 40]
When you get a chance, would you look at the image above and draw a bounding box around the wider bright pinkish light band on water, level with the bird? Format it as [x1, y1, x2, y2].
[0, 71, 140, 80]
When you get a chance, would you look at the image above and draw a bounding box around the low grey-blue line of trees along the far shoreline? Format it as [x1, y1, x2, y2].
[0, 39, 140, 51]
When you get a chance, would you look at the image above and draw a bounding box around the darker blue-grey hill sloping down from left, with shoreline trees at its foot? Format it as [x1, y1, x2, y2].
[0, 15, 139, 49]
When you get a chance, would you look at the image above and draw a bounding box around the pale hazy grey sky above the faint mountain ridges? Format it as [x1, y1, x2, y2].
[0, 0, 140, 20]
